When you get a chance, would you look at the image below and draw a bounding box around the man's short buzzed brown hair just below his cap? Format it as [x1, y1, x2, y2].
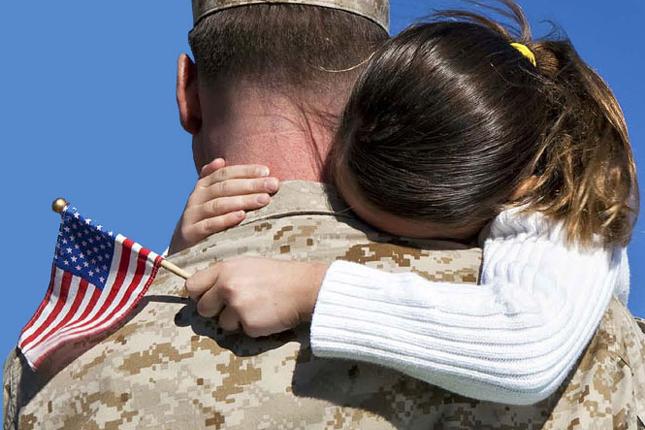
[189, 4, 388, 89]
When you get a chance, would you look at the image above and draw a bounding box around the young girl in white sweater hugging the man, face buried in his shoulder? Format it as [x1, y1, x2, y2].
[174, 0, 638, 404]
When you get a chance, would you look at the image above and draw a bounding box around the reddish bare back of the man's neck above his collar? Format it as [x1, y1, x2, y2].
[194, 88, 341, 182]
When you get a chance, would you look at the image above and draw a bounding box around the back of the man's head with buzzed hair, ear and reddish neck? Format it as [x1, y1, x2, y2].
[177, 0, 387, 179]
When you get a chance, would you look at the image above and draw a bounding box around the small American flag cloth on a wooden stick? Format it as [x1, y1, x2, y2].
[18, 206, 163, 370]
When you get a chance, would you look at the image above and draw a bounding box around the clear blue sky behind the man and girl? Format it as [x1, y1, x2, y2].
[0, 0, 645, 358]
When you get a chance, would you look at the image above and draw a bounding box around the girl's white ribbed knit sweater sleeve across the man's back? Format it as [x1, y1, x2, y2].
[311, 210, 629, 405]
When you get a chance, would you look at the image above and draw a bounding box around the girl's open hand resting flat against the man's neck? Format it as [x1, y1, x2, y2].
[169, 158, 280, 254]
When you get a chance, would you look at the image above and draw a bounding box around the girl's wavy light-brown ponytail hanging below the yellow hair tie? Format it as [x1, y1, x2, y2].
[528, 40, 638, 246]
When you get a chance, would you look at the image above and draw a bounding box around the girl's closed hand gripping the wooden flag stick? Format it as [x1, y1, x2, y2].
[186, 258, 329, 337]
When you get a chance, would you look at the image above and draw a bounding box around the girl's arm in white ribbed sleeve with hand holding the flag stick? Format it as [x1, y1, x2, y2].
[183, 170, 629, 404]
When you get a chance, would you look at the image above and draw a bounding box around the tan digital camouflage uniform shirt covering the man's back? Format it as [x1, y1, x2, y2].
[4, 182, 645, 430]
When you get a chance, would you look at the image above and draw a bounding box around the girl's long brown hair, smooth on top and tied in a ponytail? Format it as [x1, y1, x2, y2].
[332, 0, 639, 246]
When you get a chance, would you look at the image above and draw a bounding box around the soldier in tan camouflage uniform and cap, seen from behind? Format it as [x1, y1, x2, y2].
[4, 0, 645, 429]
